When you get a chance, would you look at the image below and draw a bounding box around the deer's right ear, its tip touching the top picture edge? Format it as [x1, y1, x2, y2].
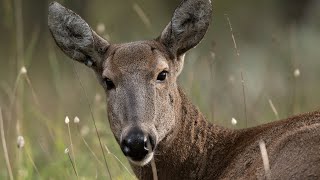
[158, 0, 212, 57]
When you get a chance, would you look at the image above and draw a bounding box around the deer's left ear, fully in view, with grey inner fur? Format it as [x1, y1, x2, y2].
[48, 2, 109, 66]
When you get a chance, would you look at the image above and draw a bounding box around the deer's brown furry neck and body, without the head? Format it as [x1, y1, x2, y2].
[132, 88, 320, 180]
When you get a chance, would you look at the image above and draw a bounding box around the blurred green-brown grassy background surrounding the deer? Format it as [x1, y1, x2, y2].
[0, 0, 320, 179]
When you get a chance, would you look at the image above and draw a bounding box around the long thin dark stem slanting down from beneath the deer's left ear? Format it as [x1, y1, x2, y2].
[72, 62, 112, 180]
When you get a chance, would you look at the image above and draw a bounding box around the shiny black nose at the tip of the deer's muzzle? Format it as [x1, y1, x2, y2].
[121, 129, 154, 161]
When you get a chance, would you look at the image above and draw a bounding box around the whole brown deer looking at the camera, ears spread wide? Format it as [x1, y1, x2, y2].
[48, 0, 320, 180]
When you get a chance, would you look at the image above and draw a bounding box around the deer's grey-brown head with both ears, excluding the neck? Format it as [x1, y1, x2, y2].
[48, 0, 212, 166]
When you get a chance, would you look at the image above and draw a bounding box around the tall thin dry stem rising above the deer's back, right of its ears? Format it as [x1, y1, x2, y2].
[225, 14, 248, 127]
